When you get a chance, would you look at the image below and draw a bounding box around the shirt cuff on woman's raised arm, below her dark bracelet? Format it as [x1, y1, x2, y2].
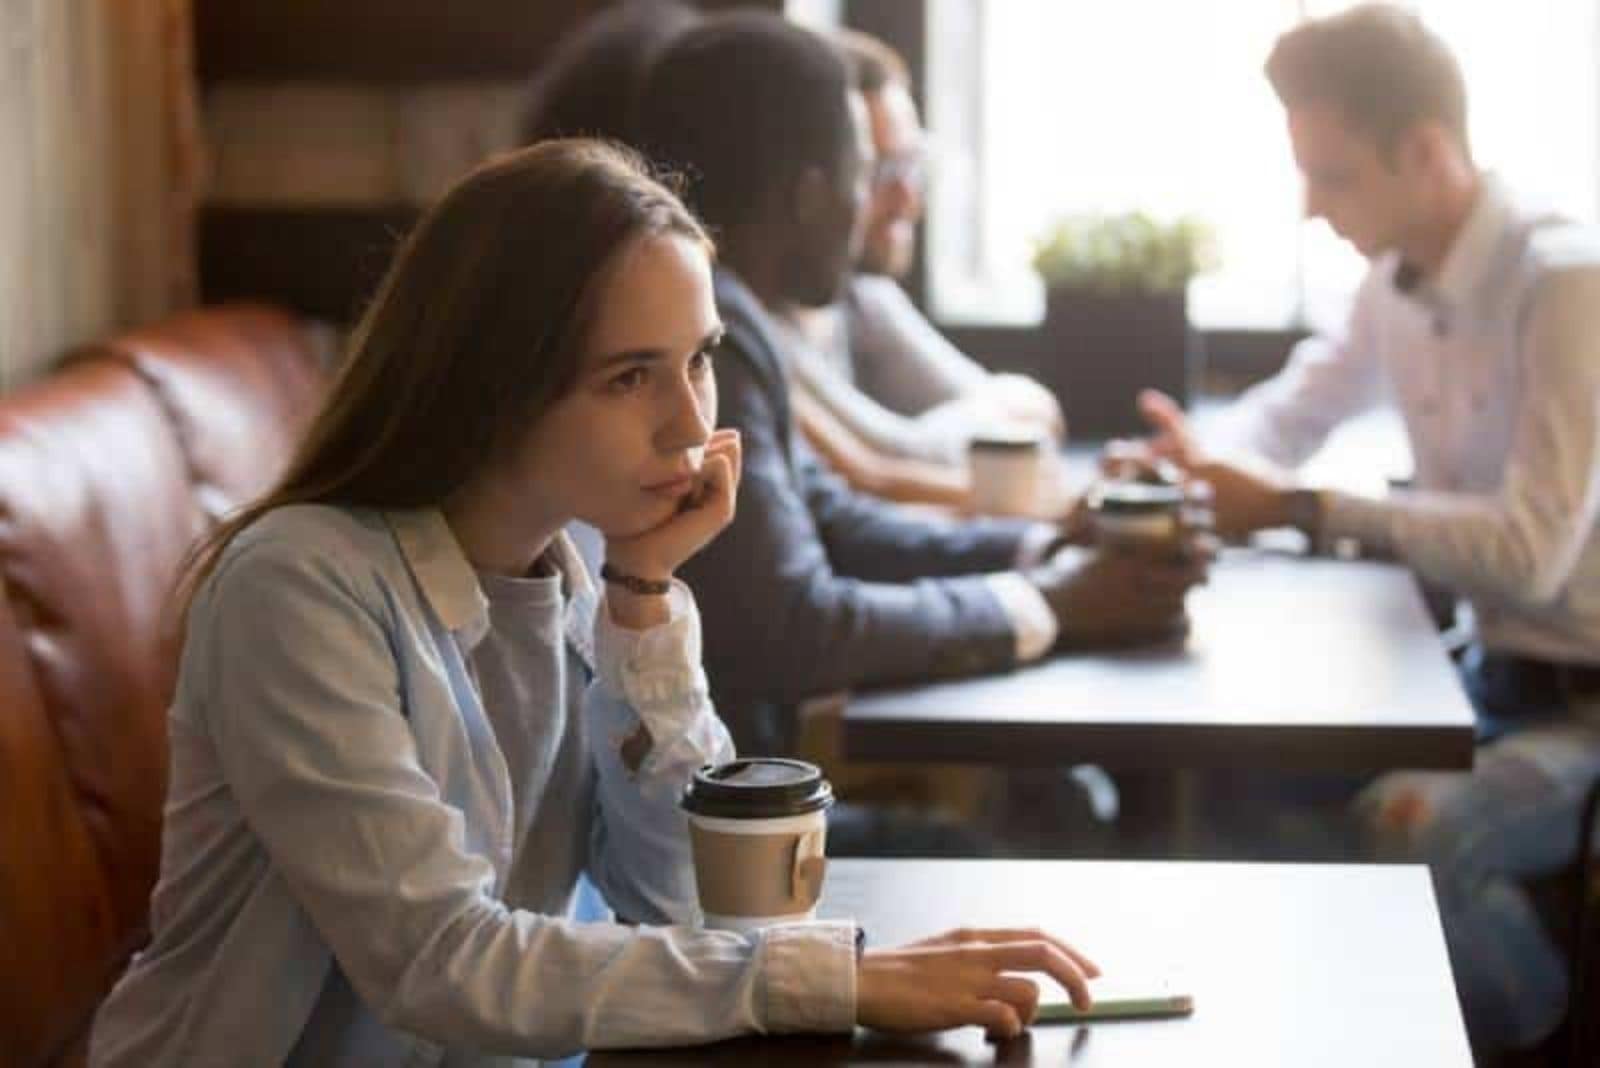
[595, 579, 707, 716]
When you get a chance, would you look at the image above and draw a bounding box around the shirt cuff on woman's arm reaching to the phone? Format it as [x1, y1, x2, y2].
[760, 921, 856, 1033]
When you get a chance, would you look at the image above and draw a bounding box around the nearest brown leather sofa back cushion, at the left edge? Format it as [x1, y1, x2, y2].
[0, 361, 205, 1063]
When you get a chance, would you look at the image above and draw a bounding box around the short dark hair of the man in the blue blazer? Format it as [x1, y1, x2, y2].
[638, 11, 854, 227]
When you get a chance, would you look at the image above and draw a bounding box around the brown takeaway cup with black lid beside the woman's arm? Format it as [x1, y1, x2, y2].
[683, 756, 834, 934]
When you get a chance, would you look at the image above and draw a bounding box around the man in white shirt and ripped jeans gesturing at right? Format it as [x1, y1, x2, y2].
[1141, 5, 1600, 1050]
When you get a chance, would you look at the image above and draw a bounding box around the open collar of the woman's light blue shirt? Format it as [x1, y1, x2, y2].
[384, 508, 594, 649]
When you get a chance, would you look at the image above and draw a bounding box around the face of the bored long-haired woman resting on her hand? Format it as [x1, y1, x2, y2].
[517, 235, 722, 537]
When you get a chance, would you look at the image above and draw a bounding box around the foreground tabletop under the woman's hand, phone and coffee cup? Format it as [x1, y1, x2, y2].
[587, 860, 1472, 1068]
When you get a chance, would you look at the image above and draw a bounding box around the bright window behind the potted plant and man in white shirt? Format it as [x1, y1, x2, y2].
[926, 0, 1600, 328]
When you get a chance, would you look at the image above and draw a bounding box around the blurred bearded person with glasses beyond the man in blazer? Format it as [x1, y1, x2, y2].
[773, 30, 1069, 515]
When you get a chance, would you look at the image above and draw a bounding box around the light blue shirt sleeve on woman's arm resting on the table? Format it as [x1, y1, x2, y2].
[204, 542, 854, 1057]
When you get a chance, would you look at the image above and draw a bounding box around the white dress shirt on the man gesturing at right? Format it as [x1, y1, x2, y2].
[1226, 176, 1600, 662]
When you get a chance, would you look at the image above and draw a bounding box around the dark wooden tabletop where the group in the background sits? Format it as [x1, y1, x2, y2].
[843, 550, 1472, 772]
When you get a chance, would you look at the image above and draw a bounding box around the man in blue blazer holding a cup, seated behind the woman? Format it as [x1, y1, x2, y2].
[637, 13, 1205, 753]
